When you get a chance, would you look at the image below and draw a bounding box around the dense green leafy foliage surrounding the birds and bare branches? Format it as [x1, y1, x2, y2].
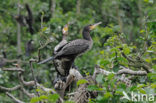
[0, 0, 156, 103]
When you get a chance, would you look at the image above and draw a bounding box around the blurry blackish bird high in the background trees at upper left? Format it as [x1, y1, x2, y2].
[15, 4, 34, 34]
